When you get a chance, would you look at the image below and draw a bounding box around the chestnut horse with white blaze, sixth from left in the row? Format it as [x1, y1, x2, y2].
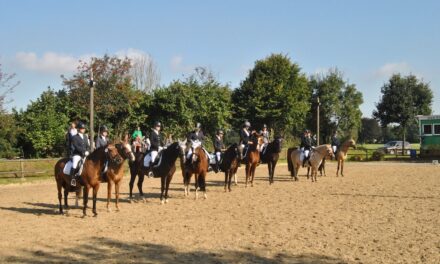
[240, 132, 263, 187]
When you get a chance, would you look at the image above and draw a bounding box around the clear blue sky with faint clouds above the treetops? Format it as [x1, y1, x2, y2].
[0, 0, 440, 116]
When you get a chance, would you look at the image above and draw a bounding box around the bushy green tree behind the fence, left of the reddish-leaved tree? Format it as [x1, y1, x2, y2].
[15, 87, 69, 157]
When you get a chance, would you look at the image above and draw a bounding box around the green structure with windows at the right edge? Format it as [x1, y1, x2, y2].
[417, 115, 440, 157]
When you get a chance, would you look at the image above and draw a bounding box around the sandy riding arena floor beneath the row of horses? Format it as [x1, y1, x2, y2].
[0, 162, 440, 263]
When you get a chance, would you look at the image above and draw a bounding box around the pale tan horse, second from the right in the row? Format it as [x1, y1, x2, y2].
[288, 144, 334, 182]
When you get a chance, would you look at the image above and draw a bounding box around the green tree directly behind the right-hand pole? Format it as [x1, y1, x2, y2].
[308, 68, 363, 141]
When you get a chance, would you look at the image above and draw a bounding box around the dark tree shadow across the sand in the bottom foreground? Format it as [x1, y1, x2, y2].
[0, 238, 346, 264]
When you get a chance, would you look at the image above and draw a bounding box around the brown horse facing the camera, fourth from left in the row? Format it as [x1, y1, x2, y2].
[184, 142, 209, 200]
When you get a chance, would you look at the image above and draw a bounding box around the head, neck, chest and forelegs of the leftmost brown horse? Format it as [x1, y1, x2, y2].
[81, 144, 124, 216]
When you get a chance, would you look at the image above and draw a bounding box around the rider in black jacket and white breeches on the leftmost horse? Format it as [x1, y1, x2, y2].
[70, 122, 90, 186]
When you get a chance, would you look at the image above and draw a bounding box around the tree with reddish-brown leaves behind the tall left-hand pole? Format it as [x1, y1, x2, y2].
[63, 55, 144, 136]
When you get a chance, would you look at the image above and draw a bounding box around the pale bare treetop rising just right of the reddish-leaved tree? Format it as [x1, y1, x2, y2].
[130, 55, 160, 93]
